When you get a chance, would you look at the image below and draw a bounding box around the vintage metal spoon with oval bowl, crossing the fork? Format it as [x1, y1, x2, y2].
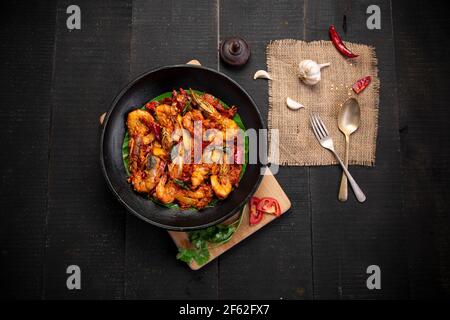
[338, 98, 361, 201]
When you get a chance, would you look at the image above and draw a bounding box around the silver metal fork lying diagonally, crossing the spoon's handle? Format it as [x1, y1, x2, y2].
[309, 113, 366, 202]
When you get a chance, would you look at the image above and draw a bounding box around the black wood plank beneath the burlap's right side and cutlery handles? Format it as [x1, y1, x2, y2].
[306, 1, 408, 299]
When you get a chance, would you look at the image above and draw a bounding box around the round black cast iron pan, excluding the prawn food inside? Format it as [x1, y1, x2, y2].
[100, 65, 265, 231]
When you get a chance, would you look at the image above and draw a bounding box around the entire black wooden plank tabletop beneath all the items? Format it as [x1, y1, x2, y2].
[0, 0, 450, 299]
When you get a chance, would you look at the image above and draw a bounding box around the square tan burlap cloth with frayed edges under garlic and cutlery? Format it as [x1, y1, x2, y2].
[267, 39, 380, 166]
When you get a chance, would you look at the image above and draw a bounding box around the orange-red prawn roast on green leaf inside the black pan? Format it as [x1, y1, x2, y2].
[122, 88, 246, 210]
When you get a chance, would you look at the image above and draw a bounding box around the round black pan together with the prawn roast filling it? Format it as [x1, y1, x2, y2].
[99, 65, 266, 231]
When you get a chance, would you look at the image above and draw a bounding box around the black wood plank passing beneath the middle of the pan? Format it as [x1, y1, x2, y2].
[126, 0, 217, 299]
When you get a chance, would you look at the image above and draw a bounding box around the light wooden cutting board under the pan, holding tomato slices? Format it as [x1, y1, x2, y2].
[169, 169, 291, 270]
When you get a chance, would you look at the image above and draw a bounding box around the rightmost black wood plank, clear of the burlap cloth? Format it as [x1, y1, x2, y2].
[392, 1, 450, 299]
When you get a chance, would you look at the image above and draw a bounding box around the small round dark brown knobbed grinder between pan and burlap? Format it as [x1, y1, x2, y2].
[219, 37, 251, 66]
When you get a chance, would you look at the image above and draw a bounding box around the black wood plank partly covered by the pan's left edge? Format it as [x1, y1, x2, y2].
[44, 0, 131, 299]
